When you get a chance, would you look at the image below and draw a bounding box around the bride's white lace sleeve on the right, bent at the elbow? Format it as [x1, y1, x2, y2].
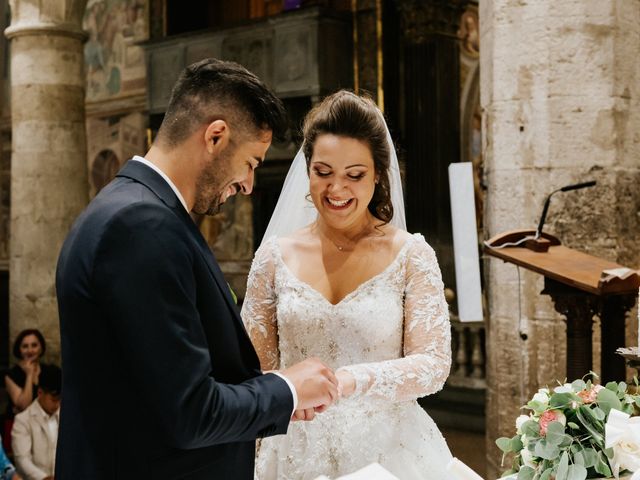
[342, 238, 451, 402]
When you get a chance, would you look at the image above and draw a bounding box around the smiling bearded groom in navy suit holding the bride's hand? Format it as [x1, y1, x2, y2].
[55, 59, 337, 479]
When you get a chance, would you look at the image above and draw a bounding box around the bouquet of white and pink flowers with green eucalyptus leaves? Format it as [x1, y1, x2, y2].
[496, 372, 640, 480]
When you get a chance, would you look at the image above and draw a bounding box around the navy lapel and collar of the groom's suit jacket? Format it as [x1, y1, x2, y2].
[117, 160, 244, 330]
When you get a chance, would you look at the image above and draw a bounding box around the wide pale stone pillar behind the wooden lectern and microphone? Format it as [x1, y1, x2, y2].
[480, 0, 640, 478]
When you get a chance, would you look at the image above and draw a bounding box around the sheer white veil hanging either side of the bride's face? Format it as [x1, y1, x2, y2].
[261, 112, 407, 245]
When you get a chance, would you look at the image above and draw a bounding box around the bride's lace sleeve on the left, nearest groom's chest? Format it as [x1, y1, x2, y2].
[241, 237, 280, 370]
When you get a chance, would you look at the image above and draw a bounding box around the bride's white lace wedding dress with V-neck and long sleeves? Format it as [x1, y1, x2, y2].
[242, 234, 451, 480]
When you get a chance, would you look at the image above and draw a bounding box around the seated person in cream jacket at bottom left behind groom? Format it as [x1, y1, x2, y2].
[11, 365, 62, 480]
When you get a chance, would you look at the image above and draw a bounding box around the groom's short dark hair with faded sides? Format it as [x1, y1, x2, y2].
[157, 58, 288, 148]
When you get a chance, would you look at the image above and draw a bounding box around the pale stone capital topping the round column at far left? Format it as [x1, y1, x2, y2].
[5, 0, 87, 41]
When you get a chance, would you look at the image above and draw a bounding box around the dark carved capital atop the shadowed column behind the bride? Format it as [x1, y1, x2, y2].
[396, 0, 469, 44]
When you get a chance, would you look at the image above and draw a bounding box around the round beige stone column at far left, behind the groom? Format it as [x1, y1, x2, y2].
[5, 0, 88, 361]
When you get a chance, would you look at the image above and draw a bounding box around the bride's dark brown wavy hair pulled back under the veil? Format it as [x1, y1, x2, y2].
[302, 90, 393, 224]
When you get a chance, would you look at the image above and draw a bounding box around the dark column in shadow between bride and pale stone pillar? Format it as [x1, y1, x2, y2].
[397, 0, 467, 286]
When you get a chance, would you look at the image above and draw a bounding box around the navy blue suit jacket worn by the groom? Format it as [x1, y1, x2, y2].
[55, 161, 293, 480]
